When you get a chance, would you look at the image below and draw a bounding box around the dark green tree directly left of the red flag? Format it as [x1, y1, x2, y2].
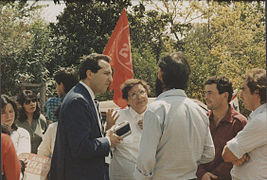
[49, 1, 132, 68]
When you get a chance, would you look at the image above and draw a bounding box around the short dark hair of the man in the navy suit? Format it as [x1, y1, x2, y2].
[79, 53, 110, 79]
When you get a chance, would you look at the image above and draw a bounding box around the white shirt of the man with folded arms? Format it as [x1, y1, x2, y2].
[227, 103, 267, 180]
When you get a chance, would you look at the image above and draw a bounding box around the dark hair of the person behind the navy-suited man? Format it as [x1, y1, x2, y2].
[54, 68, 78, 94]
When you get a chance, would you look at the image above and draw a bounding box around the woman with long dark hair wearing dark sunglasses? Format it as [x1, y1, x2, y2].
[17, 90, 48, 154]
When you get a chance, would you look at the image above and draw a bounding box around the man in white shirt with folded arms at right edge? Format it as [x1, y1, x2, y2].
[223, 69, 267, 180]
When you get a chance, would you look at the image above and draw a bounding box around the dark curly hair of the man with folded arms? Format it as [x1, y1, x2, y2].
[244, 68, 266, 104]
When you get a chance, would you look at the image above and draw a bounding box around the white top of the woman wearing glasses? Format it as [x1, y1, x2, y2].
[110, 107, 144, 180]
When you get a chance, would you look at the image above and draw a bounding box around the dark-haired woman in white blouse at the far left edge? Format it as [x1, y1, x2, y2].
[1, 95, 31, 155]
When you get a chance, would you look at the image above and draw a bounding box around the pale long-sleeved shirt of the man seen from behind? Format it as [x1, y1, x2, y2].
[134, 89, 215, 180]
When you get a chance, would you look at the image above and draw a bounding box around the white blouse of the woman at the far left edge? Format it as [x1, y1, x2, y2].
[10, 127, 31, 155]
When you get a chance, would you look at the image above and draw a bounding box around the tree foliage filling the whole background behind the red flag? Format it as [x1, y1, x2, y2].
[0, 0, 266, 114]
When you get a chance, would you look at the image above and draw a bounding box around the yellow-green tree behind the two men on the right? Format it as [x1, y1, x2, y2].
[184, 2, 266, 115]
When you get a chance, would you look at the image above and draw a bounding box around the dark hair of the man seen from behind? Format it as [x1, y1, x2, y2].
[158, 52, 191, 90]
